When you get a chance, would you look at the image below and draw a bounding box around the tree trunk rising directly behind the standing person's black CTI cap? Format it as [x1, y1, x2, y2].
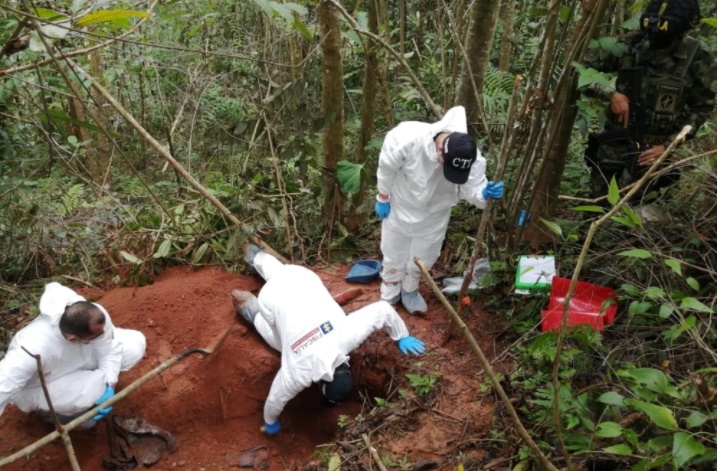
[459, 0, 499, 137]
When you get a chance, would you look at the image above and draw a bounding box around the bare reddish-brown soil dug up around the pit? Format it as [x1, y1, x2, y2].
[0, 265, 514, 471]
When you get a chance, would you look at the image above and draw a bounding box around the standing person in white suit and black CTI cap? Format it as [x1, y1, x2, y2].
[375, 106, 504, 314]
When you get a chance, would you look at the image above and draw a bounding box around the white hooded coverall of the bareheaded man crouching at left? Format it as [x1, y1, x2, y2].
[0, 283, 146, 416]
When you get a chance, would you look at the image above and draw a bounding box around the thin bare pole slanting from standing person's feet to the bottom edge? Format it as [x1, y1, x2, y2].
[414, 258, 558, 471]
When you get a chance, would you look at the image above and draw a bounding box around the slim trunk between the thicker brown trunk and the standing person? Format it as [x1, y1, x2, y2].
[346, 0, 379, 233]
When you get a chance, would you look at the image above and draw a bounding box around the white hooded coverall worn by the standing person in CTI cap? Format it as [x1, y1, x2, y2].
[377, 106, 487, 301]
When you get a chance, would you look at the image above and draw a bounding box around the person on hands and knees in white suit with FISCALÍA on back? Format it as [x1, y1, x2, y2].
[232, 245, 425, 435]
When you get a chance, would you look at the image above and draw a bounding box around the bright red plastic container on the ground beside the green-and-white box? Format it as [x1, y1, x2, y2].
[541, 276, 618, 332]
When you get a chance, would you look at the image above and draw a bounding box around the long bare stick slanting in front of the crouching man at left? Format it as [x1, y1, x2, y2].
[0, 329, 230, 468]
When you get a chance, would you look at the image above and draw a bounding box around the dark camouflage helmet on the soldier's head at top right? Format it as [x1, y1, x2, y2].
[640, 0, 701, 36]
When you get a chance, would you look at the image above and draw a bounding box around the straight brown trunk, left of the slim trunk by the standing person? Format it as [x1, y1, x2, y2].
[317, 2, 344, 228]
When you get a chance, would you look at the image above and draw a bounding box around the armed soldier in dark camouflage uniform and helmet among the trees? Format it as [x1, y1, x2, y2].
[582, 0, 716, 206]
